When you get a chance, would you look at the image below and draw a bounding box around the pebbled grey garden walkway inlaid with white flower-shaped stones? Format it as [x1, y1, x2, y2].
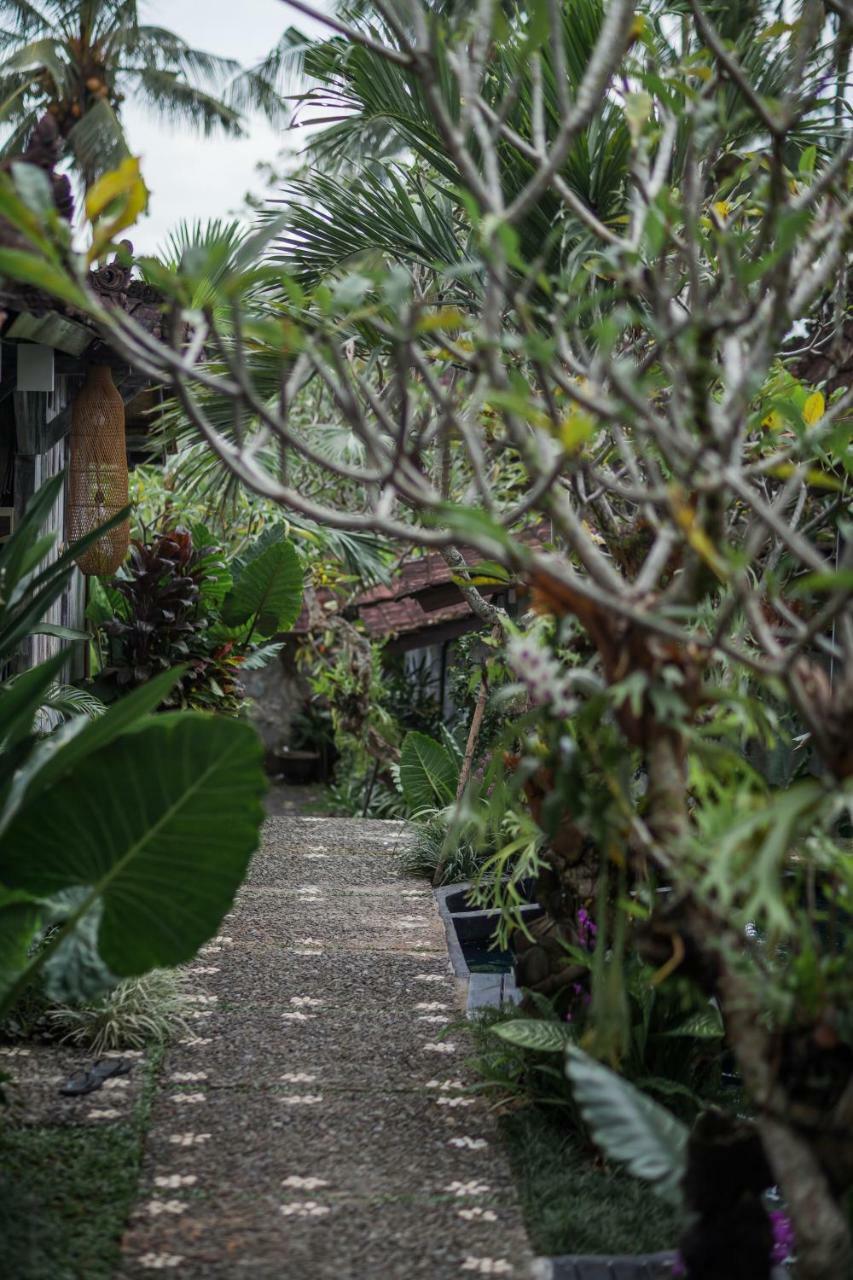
[118, 817, 532, 1280]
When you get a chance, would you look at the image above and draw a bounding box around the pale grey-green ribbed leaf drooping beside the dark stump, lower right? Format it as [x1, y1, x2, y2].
[566, 1046, 688, 1206]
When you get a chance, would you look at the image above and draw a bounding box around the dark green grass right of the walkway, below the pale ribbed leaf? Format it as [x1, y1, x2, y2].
[501, 1106, 681, 1257]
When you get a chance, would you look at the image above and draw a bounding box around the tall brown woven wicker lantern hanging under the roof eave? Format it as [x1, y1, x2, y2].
[65, 365, 131, 577]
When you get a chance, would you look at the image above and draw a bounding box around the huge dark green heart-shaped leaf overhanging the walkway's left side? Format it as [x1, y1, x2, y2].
[0, 712, 265, 977]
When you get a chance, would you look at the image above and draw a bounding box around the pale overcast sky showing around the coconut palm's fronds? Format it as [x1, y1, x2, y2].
[123, 0, 325, 253]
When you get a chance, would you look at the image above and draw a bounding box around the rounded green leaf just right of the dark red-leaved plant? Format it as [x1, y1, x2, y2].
[222, 540, 305, 636]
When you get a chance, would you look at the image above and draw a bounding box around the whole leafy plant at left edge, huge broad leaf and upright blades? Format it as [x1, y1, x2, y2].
[0, 476, 265, 1015]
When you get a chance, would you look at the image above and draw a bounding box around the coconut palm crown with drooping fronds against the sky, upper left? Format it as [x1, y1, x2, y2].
[0, 0, 286, 183]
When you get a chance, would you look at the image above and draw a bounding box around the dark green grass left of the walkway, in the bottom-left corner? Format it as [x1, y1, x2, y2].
[0, 1050, 161, 1280]
